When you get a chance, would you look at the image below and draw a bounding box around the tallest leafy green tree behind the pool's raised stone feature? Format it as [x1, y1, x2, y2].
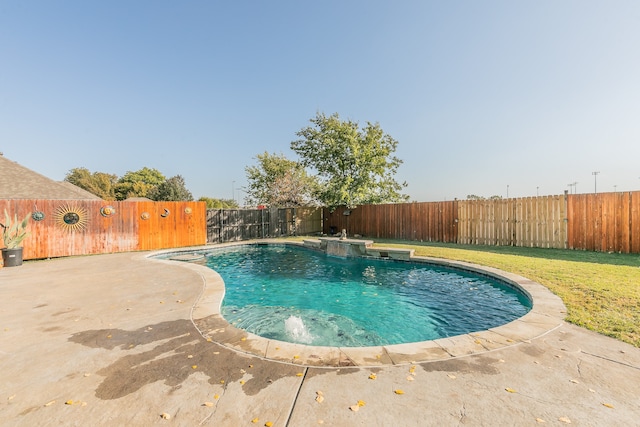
[291, 113, 409, 208]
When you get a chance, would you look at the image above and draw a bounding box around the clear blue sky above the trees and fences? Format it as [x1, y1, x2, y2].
[0, 0, 640, 201]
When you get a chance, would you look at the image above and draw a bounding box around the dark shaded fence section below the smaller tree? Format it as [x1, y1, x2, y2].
[207, 208, 322, 243]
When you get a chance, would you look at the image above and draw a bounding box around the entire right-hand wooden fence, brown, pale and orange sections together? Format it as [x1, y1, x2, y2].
[323, 191, 640, 253]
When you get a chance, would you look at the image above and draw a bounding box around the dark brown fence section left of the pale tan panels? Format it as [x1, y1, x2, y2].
[323, 200, 460, 243]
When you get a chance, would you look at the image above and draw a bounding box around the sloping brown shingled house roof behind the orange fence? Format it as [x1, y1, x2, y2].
[0, 155, 101, 200]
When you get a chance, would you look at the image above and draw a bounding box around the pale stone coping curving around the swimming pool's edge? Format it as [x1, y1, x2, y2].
[147, 239, 566, 368]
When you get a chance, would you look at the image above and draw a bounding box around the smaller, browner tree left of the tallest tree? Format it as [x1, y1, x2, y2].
[245, 151, 317, 207]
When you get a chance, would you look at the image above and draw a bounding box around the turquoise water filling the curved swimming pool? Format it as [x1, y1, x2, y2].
[196, 244, 531, 347]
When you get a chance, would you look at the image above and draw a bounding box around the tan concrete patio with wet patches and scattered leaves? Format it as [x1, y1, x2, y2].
[0, 249, 640, 426]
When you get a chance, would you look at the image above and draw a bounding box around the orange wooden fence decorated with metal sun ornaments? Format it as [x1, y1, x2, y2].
[0, 199, 206, 259]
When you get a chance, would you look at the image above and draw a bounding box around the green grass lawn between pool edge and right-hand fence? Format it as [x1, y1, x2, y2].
[288, 239, 640, 347]
